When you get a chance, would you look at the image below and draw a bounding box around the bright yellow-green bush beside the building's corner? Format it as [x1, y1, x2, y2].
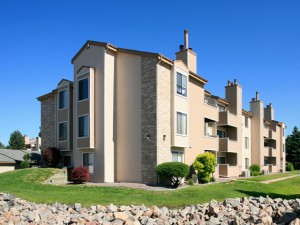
[193, 152, 217, 183]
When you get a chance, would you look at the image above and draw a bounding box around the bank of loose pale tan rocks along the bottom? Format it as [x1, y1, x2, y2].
[0, 193, 300, 225]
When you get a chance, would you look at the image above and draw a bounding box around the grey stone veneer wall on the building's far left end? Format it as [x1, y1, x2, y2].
[41, 95, 56, 150]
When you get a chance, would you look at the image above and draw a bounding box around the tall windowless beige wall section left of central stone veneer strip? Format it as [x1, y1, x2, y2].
[115, 53, 142, 182]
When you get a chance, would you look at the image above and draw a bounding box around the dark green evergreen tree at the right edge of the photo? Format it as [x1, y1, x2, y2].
[286, 127, 300, 169]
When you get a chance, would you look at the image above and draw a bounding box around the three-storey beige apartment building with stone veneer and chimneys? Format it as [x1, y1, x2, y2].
[38, 30, 285, 183]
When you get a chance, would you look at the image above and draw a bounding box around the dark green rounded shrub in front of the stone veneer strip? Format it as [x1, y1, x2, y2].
[156, 162, 189, 187]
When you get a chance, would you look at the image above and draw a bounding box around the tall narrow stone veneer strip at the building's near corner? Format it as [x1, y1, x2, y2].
[141, 57, 157, 184]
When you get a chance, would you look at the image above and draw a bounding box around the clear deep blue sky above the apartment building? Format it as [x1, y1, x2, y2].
[0, 0, 300, 144]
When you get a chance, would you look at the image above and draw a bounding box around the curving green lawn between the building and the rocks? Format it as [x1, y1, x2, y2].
[0, 168, 300, 208]
